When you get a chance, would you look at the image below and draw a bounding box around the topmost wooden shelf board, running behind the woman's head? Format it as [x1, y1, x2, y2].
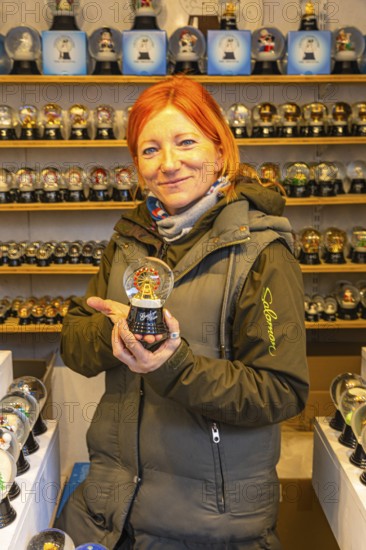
[1, 74, 366, 86]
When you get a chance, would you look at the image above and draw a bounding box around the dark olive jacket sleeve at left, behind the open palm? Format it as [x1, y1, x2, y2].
[61, 241, 120, 377]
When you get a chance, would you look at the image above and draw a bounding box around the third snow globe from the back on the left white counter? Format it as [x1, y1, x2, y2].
[0, 408, 30, 476]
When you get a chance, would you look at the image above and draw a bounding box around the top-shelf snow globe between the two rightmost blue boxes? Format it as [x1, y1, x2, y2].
[252, 27, 285, 74]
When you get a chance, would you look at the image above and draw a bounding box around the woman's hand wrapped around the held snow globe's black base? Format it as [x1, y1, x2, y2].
[112, 309, 181, 374]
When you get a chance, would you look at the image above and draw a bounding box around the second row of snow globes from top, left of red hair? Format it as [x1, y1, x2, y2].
[0, 103, 127, 141]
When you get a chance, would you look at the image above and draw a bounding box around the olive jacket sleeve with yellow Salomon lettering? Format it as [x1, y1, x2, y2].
[144, 241, 309, 427]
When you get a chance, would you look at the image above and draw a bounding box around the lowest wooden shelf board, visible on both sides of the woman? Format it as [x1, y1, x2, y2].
[0, 319, 366, 334]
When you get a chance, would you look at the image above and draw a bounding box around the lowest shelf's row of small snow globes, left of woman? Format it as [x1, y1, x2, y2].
[0, 296, 71, 325]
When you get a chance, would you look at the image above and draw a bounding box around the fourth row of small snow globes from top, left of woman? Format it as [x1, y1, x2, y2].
[0, 240, 107, 267]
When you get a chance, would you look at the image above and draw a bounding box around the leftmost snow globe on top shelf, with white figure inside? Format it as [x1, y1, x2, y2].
[5, 26, 41, 74]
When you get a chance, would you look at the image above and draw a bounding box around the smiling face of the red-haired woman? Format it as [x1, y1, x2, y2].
[137, 106, 222, 215]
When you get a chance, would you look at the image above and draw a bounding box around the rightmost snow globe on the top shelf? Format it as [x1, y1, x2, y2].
[332, 27, 365, 74]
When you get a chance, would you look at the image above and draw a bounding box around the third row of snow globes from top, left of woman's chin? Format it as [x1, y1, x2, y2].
[0, 165, 137, 204]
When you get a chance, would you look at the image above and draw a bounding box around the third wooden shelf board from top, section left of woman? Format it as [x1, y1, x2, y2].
[0, 201, 139, 212]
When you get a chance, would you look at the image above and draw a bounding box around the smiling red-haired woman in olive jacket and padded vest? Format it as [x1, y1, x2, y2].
[57, 76, 308, 550]
